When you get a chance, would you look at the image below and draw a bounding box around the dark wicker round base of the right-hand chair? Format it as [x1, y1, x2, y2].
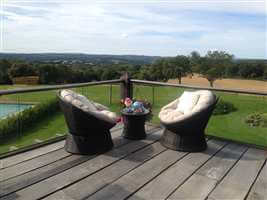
[160, 129, 207, 152]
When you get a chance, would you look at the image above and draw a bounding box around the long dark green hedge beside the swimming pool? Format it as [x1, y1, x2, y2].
[0, 98, 59, 139]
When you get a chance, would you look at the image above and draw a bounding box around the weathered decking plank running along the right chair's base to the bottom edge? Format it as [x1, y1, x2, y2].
[129, 140, 226, 199]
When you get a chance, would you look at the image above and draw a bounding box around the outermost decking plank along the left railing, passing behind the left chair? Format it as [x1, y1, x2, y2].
[0, 123, 123, 169]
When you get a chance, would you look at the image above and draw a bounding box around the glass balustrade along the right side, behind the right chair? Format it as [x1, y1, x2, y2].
[138, 85, 267, 147]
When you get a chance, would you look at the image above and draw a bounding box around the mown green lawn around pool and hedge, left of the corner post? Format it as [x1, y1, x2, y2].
[0, 86, 120, 154]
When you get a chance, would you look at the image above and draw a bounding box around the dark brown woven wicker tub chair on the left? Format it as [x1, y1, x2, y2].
[57, 90, 116, 154]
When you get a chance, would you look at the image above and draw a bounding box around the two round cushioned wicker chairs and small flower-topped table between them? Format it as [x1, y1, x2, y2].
[57, 90, 218, 154]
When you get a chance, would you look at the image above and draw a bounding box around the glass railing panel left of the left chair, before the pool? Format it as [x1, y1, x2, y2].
[0, 91, 66, 153]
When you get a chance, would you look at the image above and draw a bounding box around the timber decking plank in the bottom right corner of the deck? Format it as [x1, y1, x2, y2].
[247, 161, 267, 200]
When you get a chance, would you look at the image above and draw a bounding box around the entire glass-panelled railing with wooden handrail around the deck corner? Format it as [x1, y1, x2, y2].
[0, 74, 267, 155]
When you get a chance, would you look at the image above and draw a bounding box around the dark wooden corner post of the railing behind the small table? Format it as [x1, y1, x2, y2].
[120, 72, 133, 100]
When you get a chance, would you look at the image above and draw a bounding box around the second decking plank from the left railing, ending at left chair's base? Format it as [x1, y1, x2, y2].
[0, 149, 71, 182]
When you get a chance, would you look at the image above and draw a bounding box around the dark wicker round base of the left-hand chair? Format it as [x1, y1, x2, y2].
[65, 131, 113, 155]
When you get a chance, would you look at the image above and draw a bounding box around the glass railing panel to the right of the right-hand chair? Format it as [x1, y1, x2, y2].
[207, 92, 267, 146]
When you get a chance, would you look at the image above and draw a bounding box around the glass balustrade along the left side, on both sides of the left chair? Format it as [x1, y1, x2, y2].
[0, 84, 120, 154]
